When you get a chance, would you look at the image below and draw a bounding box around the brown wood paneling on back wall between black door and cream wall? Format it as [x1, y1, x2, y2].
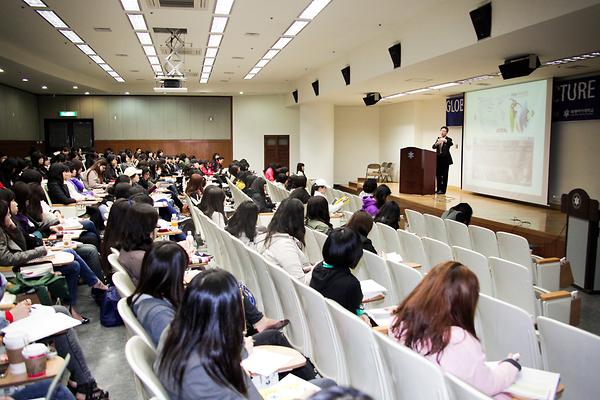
[95, 139, 233, 164]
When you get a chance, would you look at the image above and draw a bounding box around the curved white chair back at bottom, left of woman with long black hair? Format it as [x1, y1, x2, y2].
[125, 336, 169, 400]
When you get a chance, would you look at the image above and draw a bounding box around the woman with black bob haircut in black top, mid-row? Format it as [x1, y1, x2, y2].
[310, 228, 369, 322]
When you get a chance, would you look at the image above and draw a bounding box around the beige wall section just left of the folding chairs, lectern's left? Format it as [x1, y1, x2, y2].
[334, 106, 382, 185]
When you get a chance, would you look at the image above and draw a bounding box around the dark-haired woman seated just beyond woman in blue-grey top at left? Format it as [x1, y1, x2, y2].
[119, 204, 158, 285]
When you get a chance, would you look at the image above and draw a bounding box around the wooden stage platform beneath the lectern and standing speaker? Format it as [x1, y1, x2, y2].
[335, 179, 567, 257]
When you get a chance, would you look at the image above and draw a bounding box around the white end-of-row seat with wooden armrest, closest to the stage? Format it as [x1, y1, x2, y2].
[496, 232, 560, 290]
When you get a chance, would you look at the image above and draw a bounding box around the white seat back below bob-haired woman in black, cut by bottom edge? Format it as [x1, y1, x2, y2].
[327, 300, 390, 399]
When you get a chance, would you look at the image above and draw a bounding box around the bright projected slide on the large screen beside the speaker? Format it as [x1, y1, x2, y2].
[463, 80, 552, 204]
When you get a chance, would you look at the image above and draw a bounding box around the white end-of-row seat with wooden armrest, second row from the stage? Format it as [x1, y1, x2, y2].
[489, 257, 572, 322]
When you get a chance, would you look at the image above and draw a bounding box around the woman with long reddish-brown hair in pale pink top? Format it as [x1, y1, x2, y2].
[389, 261, 521, 398]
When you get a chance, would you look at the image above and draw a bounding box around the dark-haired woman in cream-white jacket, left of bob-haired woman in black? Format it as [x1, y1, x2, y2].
[256, 199, 312, 284]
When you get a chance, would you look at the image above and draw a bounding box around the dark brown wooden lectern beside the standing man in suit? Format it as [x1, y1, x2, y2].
[400, 147, 436, 195]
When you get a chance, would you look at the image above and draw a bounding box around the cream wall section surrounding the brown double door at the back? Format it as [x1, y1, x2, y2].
[233, 95, 299, 172]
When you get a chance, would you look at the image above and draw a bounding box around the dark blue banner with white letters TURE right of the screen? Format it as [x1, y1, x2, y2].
[552, 76, 600, 121]
